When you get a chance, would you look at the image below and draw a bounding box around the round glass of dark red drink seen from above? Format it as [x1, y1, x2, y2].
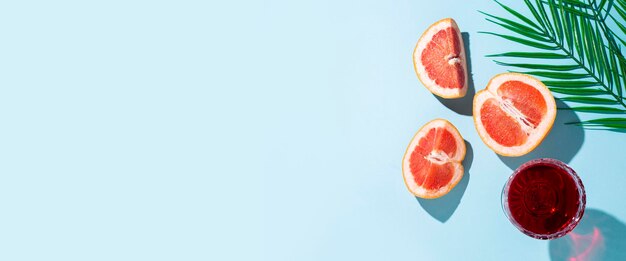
[503, 159, 585, 239]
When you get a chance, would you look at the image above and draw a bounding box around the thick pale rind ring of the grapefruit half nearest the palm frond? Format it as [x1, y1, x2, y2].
[473, 73, 557, 157]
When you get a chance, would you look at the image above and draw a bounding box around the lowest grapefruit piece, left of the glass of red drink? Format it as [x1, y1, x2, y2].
[402, 119, 465, 198]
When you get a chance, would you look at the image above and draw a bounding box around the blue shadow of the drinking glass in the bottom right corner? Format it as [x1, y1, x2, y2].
[548, 209, 626, 261]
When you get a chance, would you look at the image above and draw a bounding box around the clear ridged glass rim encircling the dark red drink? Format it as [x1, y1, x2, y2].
[501, 158, 587, 240]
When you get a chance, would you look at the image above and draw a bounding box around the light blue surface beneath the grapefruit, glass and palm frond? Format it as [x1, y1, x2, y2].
[0, 0, 626, 260]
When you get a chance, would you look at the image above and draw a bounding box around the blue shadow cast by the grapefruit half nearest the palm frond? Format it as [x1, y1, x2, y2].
[498, 100, 585, 170]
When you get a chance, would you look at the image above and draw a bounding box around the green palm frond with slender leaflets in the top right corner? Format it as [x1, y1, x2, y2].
[480, 0, 626, 130]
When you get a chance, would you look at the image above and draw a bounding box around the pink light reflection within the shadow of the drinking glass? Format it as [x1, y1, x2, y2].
[568, 227, 604, 261]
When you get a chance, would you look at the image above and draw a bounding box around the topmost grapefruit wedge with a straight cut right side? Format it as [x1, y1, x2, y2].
[413, 18, 467, 99]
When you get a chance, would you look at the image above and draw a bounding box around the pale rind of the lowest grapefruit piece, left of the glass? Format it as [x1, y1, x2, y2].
[402, 119, 466, 199]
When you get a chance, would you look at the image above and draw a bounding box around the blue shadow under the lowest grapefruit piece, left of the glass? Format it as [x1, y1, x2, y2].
[415, 141, 474, 223]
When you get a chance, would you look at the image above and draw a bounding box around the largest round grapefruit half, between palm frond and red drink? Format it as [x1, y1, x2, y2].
[473, 73, 556, 157]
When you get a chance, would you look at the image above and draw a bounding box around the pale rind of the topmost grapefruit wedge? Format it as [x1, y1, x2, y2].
[413, 18, 468, 99]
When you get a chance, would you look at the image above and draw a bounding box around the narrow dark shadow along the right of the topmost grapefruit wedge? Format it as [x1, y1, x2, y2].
[433, 32, 476, 115]
